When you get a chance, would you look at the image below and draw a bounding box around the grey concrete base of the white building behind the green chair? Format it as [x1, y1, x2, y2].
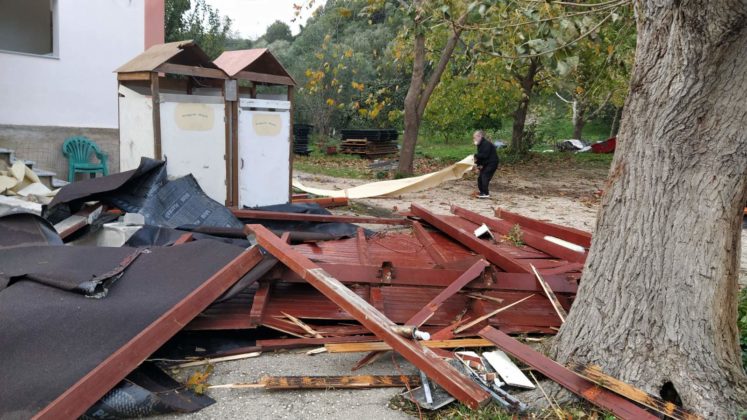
[0, 124, 119, 181]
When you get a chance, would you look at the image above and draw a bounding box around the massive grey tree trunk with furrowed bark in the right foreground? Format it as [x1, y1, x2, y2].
[555, 0, 747, 419]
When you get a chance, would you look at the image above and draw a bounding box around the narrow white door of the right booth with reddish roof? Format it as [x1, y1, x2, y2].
[238, 98, 291, 207]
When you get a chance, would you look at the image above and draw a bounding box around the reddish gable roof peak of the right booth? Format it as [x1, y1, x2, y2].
[214, 48, 296, 86]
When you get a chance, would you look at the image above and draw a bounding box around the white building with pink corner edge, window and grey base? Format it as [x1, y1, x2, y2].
[0, 0, 164, 179]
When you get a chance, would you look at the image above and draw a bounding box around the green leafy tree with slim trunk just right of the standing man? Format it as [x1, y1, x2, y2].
[471, 1, 632, 154]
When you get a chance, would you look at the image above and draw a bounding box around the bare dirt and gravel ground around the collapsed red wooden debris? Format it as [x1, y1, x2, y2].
[160, 162, 747, 419]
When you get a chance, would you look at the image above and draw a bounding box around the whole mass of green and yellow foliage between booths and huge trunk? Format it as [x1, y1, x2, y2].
[243, 0, 635, 156]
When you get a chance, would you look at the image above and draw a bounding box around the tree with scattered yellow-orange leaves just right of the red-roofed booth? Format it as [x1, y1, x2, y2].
[278, 0, 407, 135]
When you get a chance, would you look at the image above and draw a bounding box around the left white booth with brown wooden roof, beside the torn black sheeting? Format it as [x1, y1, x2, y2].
[117, 41, 232, 205]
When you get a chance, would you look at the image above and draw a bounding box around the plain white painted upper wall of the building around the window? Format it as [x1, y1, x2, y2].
[0, 0, 145, 128]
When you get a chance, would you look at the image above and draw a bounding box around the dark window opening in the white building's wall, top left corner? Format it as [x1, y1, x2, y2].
[0, 0, 57, 56]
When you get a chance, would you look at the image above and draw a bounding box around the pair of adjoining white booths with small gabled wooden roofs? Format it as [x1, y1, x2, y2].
[116, 41, 295, 207]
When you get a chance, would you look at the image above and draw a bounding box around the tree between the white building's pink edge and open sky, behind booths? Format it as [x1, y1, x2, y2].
[164, 0, 231, 59]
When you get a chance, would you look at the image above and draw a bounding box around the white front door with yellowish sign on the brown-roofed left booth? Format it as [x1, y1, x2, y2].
[161, 95, 227, 204]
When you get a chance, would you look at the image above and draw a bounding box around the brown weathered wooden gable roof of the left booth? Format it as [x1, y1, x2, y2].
[115, 40, 225, 78]
